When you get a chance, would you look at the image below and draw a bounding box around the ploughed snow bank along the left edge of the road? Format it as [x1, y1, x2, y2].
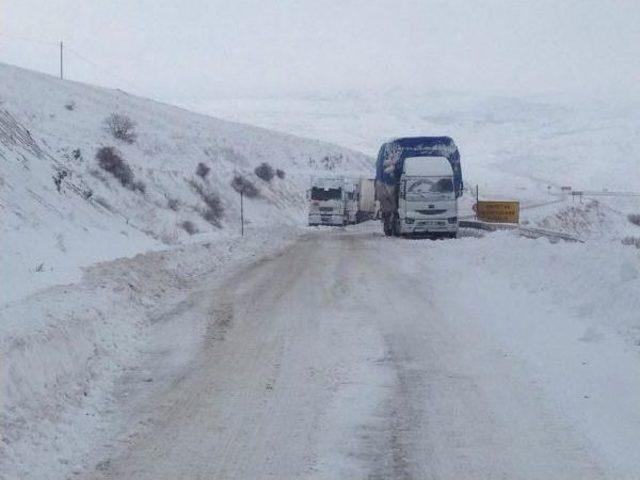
[0, 228, 297, 479]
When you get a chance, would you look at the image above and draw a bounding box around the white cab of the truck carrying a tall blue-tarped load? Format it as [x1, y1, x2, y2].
[395, 157, 458, 237]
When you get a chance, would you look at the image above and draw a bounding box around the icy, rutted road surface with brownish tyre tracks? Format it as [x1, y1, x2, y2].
[80, 225, 640, 480]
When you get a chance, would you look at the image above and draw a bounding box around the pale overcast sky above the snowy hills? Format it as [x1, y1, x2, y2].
[0, 0, 640, 101]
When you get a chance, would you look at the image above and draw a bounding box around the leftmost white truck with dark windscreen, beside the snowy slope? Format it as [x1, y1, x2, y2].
[308, 177, 349, 226]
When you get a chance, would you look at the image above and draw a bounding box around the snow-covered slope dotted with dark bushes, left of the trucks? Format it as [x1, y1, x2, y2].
[0, 64, 371, 303]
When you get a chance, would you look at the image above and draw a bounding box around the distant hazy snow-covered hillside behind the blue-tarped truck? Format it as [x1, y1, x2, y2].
[185, 91, 640, 197]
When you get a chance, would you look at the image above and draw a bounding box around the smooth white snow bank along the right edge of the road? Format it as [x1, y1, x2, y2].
[392, 232, 640, 478]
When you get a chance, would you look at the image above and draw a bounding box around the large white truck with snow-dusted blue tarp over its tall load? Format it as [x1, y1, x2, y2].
[375, 137, 463, 238]
